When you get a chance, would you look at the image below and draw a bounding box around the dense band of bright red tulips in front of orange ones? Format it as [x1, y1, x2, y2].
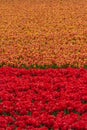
[0, 67, 87, 130]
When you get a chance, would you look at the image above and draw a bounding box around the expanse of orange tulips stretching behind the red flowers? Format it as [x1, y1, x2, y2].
[0, 0, 87, 67]
